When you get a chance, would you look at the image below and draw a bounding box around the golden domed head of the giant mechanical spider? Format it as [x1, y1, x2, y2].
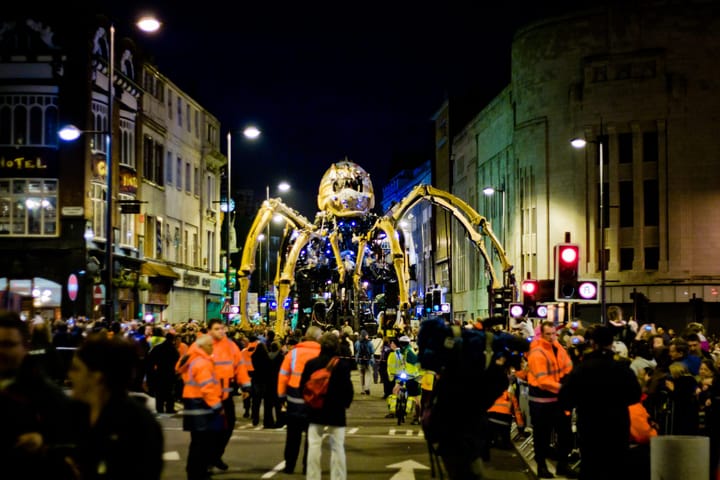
[318, 160, 375, 217]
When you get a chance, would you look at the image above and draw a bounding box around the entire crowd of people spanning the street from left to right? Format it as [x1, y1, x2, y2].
[0, 306, 720, 480]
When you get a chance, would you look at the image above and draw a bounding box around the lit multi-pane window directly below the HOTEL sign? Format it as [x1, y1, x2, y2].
[0, 178, 58, 237]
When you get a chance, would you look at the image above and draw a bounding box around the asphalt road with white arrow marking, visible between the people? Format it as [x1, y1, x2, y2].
[159, 372, 533, 480]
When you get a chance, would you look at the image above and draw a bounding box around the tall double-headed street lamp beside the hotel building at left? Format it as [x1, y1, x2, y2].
[58, 16, 160, 322]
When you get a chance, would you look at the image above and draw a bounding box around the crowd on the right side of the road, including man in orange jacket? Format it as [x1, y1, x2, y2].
[506, 306, 720, 480]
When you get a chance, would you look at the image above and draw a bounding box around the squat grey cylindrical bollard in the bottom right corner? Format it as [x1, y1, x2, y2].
[650, 435, 710, 480]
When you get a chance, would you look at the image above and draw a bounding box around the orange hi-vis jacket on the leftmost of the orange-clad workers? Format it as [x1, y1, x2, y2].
[178, 343, 222, 409]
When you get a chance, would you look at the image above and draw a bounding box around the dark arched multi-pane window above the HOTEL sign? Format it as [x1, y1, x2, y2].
[0, 94, 58, 147]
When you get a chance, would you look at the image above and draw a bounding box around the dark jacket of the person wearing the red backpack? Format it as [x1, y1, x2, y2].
[300, 353, 355, 427]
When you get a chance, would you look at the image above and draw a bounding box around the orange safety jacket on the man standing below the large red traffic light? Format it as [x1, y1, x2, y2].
[527, 338, 572, 401]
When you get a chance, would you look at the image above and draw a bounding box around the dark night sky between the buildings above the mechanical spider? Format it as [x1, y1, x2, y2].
[62, 0, 584, 219]
